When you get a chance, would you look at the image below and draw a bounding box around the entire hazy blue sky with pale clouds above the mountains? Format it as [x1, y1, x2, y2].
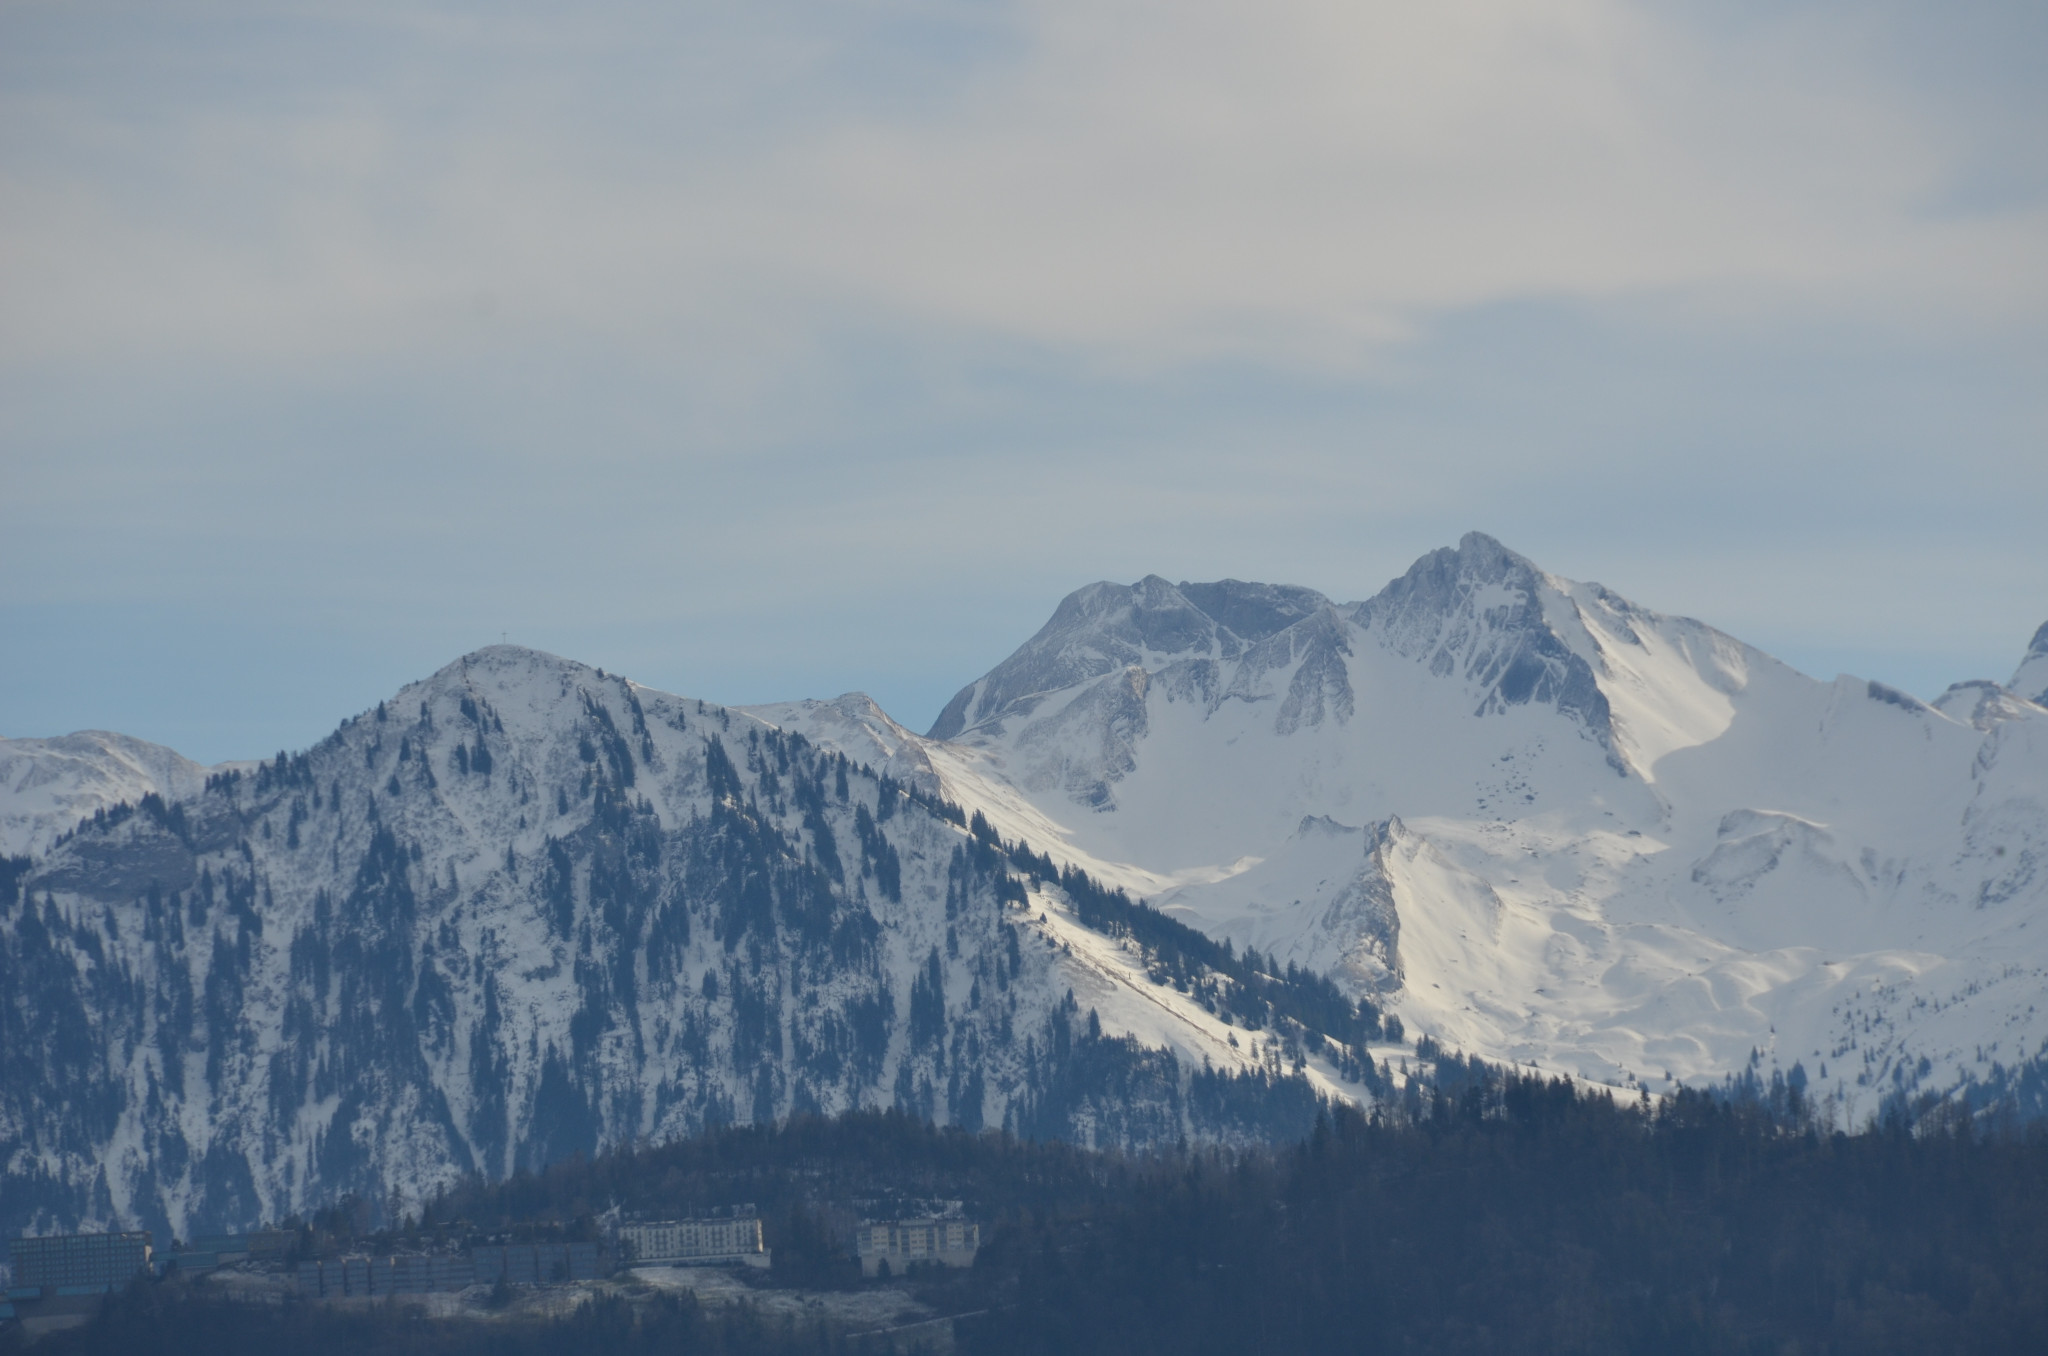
[0, 0, 2048, 762]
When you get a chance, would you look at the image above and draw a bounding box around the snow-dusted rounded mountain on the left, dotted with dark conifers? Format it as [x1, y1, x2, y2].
[0, 647, 1358, 1237]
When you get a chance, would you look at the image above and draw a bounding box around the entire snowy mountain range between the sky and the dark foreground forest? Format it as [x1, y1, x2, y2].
[0, 533, 2048, 1231]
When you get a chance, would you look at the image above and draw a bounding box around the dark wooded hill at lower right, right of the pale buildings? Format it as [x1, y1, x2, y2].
[961, 1069, 2048, 1356]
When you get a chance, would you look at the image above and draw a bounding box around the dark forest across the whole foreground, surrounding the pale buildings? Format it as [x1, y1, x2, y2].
[16, 1067, 2048, 1356]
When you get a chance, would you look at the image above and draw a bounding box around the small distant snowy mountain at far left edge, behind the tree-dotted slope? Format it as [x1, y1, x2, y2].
[0, 729, 207, 856]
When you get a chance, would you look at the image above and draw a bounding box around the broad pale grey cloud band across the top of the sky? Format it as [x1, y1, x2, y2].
[0, 0, 2048, 367]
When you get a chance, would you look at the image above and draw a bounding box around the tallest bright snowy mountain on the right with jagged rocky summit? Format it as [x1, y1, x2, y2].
[770, 535, 2048, 1116]
